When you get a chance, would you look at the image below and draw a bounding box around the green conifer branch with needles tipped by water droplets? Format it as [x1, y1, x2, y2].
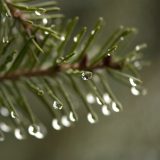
[0, 0, 146, 141]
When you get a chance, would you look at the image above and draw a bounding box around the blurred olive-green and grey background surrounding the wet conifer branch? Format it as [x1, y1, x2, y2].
[0, 0, 160, 160]
